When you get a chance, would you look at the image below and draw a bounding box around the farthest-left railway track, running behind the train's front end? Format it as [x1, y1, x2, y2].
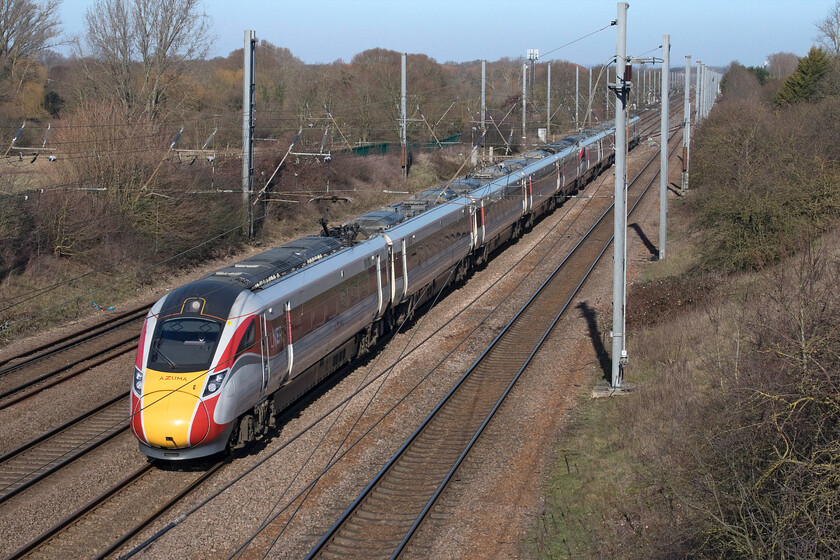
[0, 305, 148, 410]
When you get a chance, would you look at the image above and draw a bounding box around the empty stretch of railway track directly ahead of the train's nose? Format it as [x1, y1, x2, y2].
[6, 461, 227, 560]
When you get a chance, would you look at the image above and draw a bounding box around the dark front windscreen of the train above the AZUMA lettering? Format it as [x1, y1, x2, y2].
[148, 318, 222, 373]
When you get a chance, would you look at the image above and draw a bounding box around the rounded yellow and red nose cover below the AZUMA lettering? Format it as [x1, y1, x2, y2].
[143, 391, 210, 449]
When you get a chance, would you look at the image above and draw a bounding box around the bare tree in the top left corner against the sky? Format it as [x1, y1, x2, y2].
[0, 0, 61, 80]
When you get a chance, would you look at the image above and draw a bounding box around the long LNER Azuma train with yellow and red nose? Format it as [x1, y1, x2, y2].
[130, 116, 640, 461]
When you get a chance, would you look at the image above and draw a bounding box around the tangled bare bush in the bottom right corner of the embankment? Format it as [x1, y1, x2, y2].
[697, 250, 840, 558]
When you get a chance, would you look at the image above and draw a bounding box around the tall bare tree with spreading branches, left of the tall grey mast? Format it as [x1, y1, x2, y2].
[85, 0, 211, 118]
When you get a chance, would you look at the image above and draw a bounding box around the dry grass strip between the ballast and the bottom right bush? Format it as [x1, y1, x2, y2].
[537, 298, 720, 558]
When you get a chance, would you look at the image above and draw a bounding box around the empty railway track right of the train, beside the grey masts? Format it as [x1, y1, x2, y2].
[307, 124, 677, 558]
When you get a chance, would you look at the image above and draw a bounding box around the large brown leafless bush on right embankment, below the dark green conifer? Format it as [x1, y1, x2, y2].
[692, 100, 840, 272]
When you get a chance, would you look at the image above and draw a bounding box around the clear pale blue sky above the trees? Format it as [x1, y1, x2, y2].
[60, 0, 836, 67]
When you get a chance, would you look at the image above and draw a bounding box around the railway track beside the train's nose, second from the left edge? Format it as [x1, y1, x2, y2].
[0, 392, 128, 504]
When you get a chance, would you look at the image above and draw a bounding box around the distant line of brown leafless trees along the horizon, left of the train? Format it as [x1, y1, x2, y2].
[0, 0, 624, 154]
